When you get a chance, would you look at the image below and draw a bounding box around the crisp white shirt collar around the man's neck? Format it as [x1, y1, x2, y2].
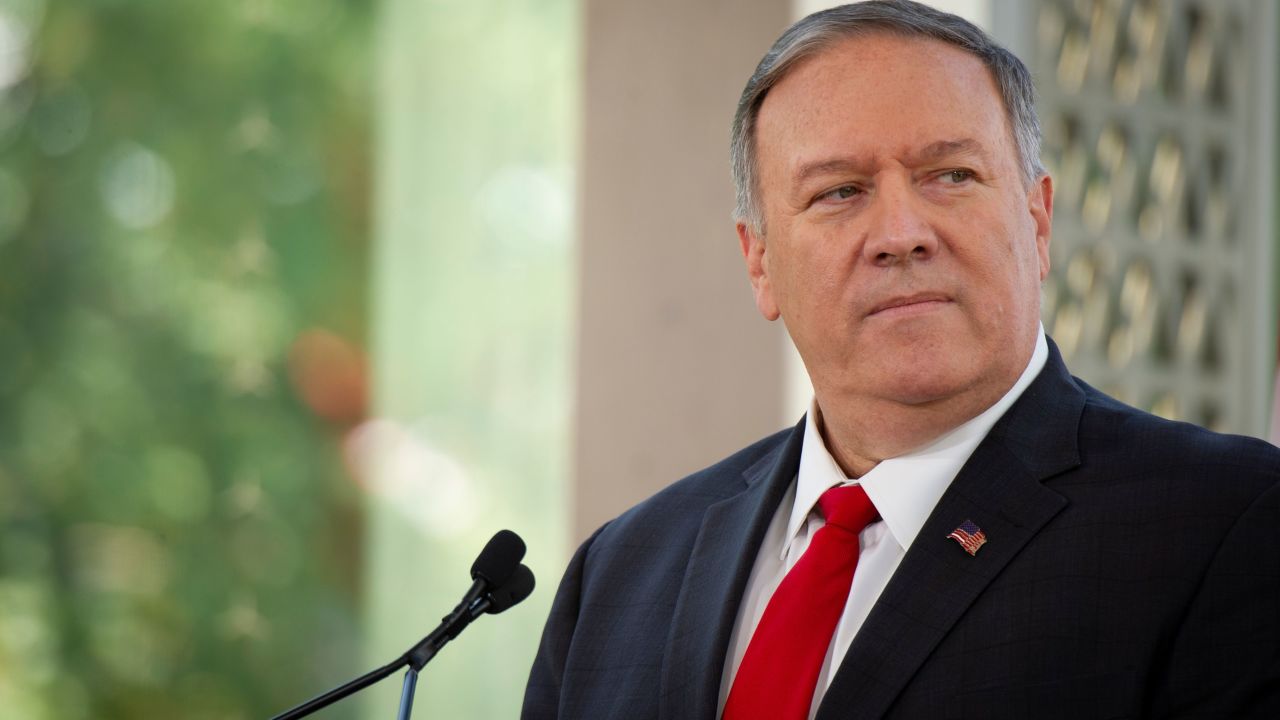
[782, 324, 1048, 553]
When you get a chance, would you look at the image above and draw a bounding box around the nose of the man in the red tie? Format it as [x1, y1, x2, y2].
[863, 178, 938, 268]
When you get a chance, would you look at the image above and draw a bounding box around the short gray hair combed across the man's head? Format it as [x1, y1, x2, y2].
[730, 0, 1044, 232]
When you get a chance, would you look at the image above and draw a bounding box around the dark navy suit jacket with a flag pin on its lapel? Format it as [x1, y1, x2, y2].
[522, 346, 1280, 720]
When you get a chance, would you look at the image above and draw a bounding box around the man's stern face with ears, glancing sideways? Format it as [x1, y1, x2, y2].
[739, 35, 1052, 406]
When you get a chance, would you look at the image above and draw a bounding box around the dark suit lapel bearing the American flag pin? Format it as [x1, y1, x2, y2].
[818, 342, 1084, 720]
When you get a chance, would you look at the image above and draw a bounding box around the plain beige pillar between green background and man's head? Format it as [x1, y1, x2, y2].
[572, 0, 791, 542]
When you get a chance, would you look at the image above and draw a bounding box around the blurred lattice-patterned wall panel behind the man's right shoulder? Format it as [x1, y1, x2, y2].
[1029, 0, 1275, 434]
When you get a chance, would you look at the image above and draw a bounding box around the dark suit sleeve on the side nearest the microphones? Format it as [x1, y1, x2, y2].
[520, 520, 604, 720]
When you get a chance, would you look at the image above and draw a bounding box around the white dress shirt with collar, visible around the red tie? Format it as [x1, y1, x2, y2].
[719, 325, 1048, 720]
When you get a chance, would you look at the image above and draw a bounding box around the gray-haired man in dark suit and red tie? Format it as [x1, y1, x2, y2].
[524, 0, 1280, 720]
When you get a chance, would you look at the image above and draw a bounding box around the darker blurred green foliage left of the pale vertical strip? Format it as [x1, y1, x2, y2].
[0, 0, 372, 720]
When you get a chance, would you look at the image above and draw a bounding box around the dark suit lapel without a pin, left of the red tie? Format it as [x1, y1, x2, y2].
[658, 420, 804, 720]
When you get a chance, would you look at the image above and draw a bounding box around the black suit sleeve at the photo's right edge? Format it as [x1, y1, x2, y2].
[1152, 469, 1280, 717]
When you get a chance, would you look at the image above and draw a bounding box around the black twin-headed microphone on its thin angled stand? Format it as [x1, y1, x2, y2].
[271, 530, 534, 720]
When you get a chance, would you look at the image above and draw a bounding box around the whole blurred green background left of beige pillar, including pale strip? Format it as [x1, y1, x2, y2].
[0, 0, 577, 720]
